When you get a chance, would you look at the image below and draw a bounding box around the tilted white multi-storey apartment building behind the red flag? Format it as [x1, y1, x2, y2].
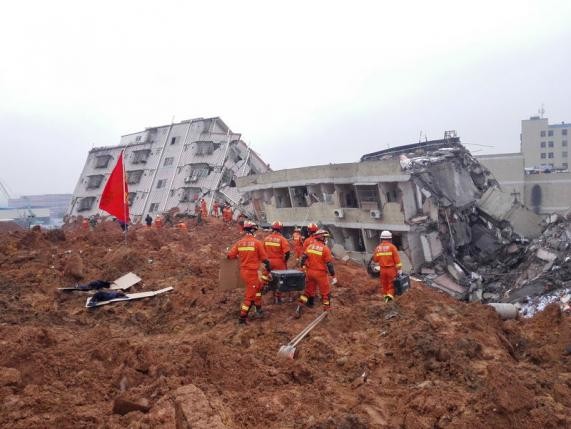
[67, 117, 269, 222]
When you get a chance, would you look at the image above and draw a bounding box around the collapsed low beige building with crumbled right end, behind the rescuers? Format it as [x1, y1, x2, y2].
[236, 133, 542, 300]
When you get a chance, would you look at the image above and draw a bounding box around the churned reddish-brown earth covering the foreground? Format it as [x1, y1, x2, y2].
[0, 220, 571, 428]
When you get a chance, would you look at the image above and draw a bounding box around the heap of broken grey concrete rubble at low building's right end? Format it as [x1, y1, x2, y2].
[368, 142, 571, 316]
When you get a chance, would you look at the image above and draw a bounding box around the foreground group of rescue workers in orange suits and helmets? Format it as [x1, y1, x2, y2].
[226, 220, 402, 324]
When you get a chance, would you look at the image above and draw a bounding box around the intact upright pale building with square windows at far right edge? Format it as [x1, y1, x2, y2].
[520, 116, 571, 170]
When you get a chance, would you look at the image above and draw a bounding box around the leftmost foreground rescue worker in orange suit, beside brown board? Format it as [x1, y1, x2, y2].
[227, 220, 271, 323]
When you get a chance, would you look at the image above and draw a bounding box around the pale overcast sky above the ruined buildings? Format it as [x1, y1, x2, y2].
[0, 0, 571, 195]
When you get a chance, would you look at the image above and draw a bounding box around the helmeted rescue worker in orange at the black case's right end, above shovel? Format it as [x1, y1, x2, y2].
[296, 229, 337, 317]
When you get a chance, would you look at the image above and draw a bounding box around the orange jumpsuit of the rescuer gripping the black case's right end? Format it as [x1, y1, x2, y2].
[299, 239, 333, 310]
